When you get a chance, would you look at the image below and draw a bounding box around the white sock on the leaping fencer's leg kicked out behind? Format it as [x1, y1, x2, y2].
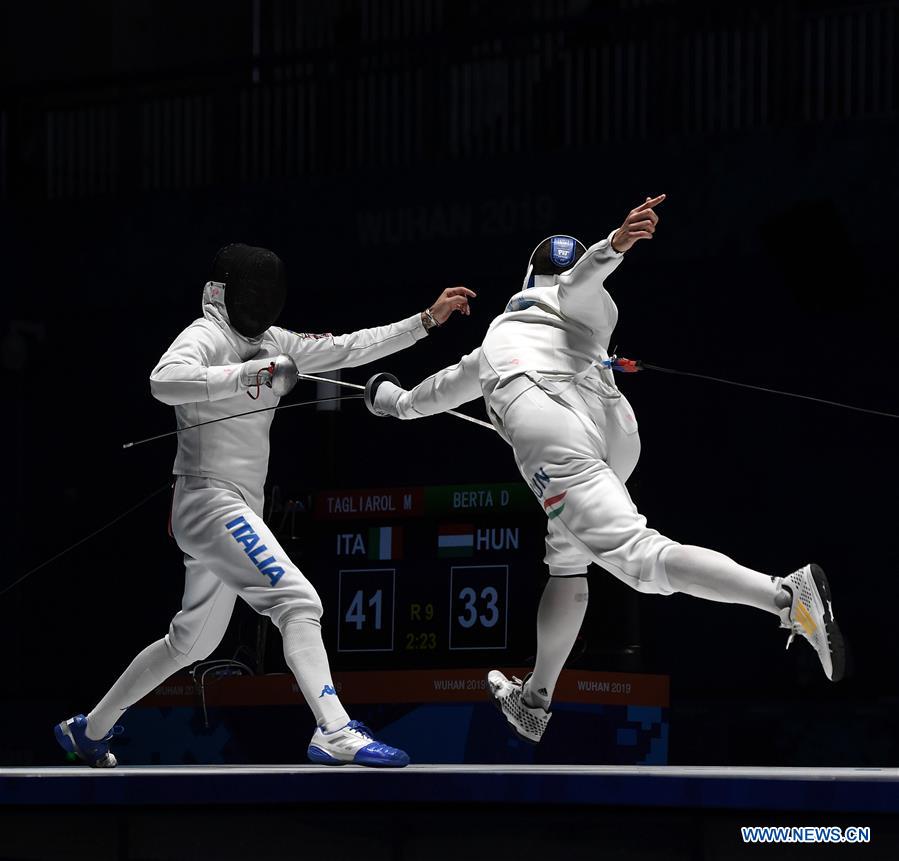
[663, 544, 790, 616]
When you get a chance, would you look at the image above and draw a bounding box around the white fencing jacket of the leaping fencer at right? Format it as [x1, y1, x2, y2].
[390, 234, 623, 436]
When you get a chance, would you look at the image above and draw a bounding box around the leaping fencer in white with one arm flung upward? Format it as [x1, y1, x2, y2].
[366, 195, 844, 742]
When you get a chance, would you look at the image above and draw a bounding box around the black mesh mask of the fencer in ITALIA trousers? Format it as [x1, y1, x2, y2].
[211, 243, 287, 338]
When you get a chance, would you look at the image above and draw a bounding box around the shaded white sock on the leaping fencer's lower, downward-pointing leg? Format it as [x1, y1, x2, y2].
[523, 577, 589, 710]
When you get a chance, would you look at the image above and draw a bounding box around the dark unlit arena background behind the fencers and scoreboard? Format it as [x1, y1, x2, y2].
[0, 0, 899, 766]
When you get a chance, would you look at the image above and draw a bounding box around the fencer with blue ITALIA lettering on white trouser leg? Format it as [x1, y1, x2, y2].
[56, 245, 474, 767]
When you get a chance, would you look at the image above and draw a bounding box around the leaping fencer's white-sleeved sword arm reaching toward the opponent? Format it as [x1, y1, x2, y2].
[373, 347, 481, 419]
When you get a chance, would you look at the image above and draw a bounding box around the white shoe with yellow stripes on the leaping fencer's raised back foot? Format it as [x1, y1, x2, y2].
[780, 563, 846, 682]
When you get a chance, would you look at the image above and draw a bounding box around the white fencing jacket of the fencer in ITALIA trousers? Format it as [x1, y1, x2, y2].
[150, 282, 427, 513]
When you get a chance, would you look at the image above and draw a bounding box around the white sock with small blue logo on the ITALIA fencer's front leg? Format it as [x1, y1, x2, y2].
[281, 619, 350, 732]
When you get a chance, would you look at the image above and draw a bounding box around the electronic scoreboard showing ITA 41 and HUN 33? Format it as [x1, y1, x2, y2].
[295, 484, 546, 670]
